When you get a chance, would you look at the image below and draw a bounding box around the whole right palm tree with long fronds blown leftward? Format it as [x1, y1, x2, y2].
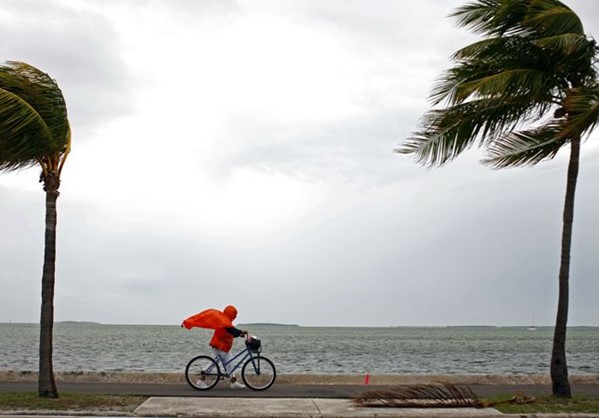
[397, 0, 599, 397]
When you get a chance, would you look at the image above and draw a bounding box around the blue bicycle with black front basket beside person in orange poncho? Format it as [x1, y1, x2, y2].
[185, 336, 277, 390]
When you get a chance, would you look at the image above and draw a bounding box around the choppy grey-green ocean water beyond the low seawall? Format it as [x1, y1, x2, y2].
[0, 323, 599, 375]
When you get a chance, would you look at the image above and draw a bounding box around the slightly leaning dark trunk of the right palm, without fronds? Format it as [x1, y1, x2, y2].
[551, 136, 580, 398]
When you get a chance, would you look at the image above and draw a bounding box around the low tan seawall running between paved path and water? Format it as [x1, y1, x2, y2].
[0, 370, 599, 385]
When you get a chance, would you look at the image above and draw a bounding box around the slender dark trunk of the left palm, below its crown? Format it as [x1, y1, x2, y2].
[38, 173, 60, 398]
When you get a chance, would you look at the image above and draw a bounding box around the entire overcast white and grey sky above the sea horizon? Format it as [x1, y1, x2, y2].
[0, 0, 599, 326]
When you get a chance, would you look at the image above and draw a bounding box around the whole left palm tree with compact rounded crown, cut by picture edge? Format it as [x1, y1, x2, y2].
[0, 62, 71, 398]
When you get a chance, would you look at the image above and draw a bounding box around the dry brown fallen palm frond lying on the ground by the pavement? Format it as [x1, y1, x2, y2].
[353, 383, 483, 408]
